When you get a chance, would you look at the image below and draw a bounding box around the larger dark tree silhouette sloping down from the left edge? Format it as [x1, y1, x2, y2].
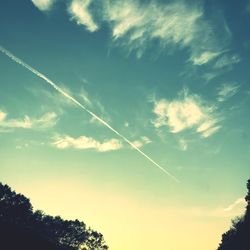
[0, 183, 108, 250]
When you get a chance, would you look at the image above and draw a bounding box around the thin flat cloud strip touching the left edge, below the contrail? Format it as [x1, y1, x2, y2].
[0, 110, 57, 129]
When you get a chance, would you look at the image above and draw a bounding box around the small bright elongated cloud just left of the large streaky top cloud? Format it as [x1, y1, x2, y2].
[68, 0, 98, 32]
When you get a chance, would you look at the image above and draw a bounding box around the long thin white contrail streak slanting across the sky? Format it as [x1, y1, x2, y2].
[0, 45, 180, 182]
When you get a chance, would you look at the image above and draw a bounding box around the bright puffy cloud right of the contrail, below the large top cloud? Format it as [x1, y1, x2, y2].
[153, 93, 220, 137]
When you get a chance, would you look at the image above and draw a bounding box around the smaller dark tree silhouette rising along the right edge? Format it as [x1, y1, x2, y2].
[218, 179, 250, 250]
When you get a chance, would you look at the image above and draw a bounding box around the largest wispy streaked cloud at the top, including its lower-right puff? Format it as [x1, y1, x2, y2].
[103, 0, 230, 62]
